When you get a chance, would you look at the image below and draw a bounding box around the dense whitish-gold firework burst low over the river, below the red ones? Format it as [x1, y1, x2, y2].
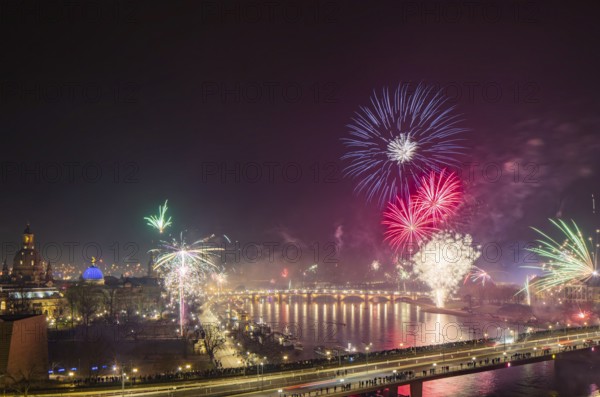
[412, 231, 481, 307]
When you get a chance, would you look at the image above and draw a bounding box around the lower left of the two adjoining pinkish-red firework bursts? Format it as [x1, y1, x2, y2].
[382, 199, 435, 252]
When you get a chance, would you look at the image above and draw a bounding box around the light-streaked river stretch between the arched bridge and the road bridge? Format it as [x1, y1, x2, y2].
[243, 300, 511, 352]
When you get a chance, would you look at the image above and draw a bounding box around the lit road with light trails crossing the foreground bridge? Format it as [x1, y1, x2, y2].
[35, 331, 600, 397]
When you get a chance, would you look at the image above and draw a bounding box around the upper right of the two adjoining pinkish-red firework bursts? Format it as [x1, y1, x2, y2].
[415, 170, 462, 224]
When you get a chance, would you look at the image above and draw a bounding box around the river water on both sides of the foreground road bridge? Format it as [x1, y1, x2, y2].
[237, 300, 600, 397]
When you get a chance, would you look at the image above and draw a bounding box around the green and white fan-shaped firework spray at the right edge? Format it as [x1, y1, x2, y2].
[523, 219, 598, 291]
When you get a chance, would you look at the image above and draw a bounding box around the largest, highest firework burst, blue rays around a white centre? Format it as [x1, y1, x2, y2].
[342, 83, 466, 207]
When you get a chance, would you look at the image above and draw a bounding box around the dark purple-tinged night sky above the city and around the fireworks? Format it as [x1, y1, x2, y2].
[0, 1, 600, 284]
